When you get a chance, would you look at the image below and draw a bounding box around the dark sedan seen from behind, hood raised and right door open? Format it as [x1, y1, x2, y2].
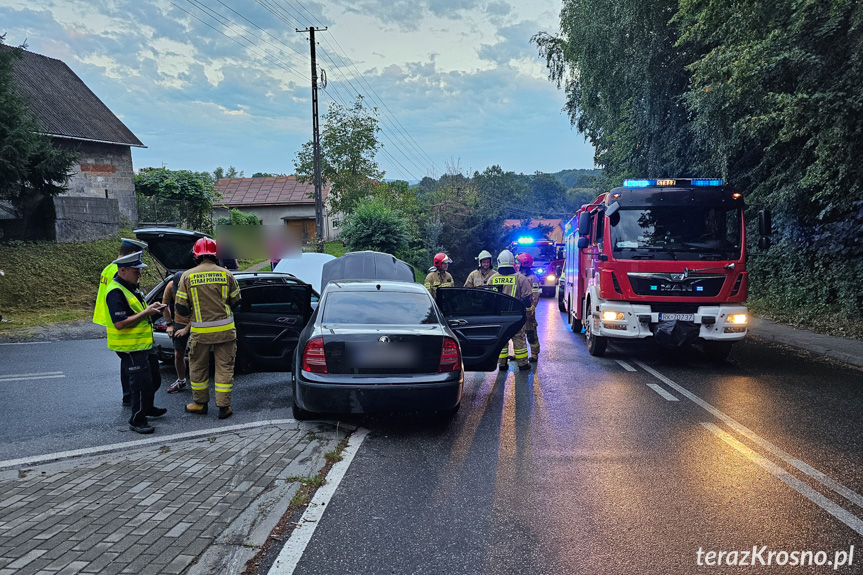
[291, 252, 525, 420]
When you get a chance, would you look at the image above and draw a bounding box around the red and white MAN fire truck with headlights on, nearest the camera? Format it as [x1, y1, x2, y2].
[563, 178, 770, 361]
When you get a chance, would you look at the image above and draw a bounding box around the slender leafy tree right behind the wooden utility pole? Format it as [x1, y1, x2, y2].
[294, 96, 384, 214]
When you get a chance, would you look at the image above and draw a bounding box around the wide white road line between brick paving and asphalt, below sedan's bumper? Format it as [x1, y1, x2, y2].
[267, 428, 369, 575]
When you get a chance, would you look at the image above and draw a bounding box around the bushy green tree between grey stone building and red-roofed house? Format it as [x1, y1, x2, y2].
[135, 168, 217, 233]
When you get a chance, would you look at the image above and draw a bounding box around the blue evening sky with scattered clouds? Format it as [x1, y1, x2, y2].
[0, 0, 593, 180]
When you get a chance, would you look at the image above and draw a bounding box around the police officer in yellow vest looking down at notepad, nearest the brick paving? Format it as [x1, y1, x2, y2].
[103, 252, 168, 433]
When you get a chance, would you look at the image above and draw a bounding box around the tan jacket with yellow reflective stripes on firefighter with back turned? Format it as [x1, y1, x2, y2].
[174, 259, 240, 344]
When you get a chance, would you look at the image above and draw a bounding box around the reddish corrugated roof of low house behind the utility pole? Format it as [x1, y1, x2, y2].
[216, 180, 329, 207]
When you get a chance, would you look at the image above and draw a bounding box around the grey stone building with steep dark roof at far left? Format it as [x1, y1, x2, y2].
[0, 45, 145, 241]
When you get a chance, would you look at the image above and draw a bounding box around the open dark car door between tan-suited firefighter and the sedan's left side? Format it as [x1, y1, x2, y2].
[234, 282, 312, 371]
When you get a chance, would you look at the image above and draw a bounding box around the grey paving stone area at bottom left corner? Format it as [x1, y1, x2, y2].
[0, 422, 347, 575]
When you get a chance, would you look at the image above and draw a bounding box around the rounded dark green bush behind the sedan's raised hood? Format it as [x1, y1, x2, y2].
[341, 196, 411, 256]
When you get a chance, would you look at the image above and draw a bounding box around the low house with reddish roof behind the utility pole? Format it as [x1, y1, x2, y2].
[213, 176, 339, 241]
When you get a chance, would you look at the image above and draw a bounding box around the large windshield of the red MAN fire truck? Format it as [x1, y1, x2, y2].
[609, 205, 742, 260]
